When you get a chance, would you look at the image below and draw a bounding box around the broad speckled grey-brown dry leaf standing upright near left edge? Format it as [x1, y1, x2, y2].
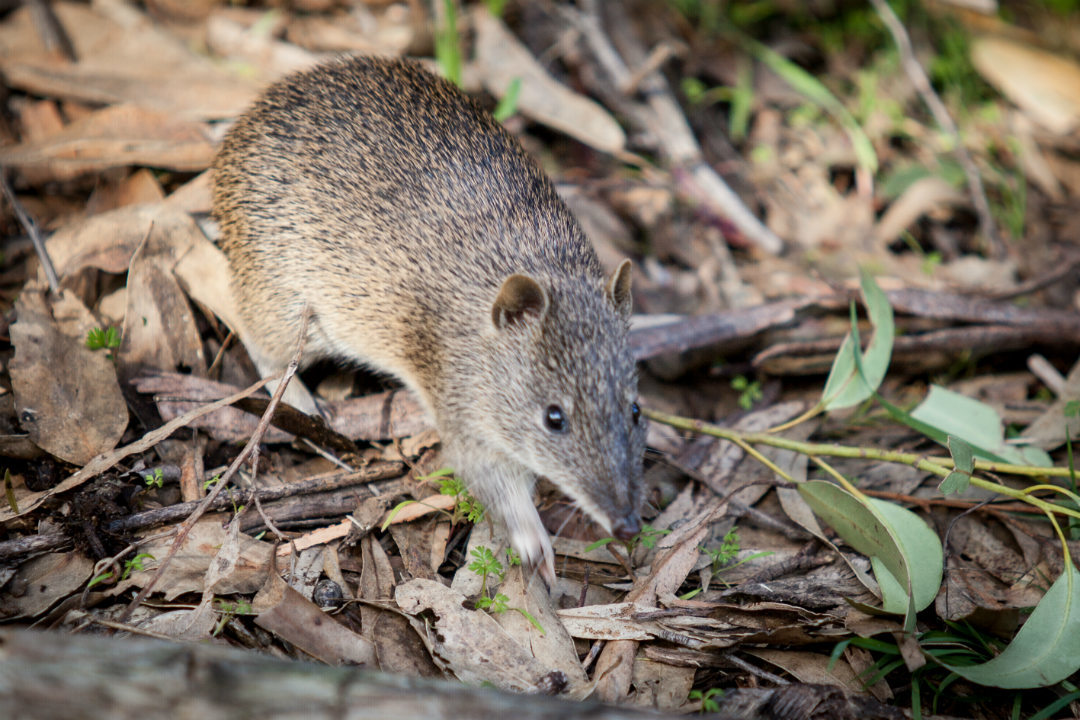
[9, 283, 127, 465]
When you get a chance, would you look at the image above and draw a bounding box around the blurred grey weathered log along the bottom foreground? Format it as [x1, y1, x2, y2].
[0, 629, 699, 720]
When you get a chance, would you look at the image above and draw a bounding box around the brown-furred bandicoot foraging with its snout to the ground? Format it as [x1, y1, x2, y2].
[214, 58, 645, 582]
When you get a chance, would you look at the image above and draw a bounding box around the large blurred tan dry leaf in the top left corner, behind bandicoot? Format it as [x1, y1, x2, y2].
[0, 2, 258, 120]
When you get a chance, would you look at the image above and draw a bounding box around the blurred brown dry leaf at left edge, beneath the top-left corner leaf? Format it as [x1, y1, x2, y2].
[0, 105, 214, 180]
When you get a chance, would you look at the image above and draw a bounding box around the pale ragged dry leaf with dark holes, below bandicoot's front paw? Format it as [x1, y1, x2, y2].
[394, 580, 555, 693]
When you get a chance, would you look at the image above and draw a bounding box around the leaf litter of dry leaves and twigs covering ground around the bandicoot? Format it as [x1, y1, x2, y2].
[0, 2, 1080, 717]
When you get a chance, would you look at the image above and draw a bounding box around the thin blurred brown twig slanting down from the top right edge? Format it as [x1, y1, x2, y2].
[870, 0, 1005, 258]
